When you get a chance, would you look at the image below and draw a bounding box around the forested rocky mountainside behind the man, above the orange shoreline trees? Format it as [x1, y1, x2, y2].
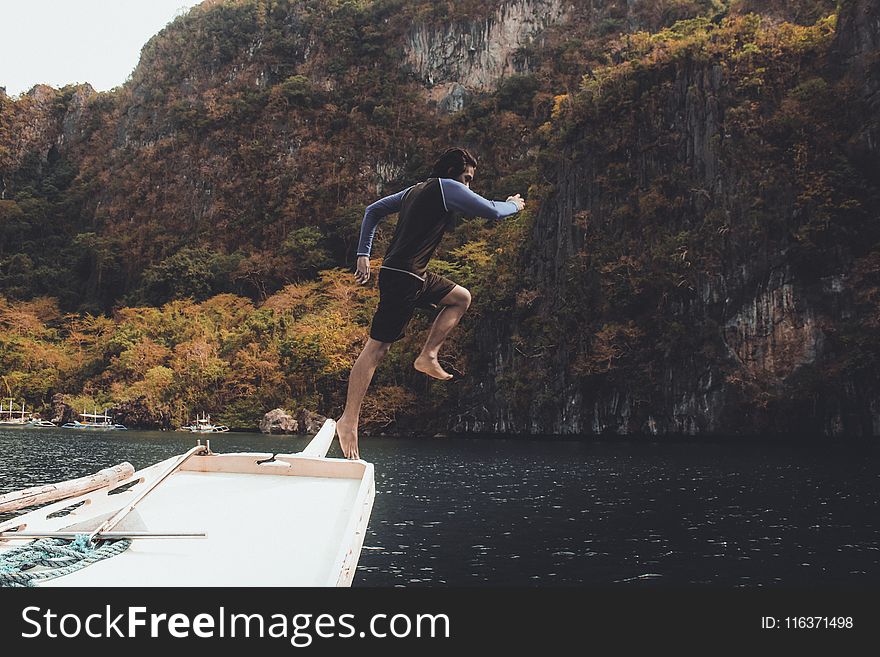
[0, 0, 880, 436]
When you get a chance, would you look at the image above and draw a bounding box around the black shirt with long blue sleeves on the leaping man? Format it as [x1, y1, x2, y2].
[358, 178, 518, 278]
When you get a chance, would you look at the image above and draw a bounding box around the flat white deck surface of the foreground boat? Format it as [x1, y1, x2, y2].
[41, 472, 360, 587]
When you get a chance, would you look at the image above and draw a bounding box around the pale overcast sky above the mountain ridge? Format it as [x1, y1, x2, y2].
[0, 0, 200, 96]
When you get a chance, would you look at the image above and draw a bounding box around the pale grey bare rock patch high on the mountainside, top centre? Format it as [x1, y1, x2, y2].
[406, 0, 568, 112]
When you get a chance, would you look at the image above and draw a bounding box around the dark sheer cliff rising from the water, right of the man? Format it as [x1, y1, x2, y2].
[454, 2, 880, 436]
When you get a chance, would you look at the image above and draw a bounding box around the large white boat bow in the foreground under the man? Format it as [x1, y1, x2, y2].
[0, 420, 375, 587]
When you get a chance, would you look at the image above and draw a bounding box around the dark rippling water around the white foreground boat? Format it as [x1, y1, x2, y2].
[0, 429, 880, 588]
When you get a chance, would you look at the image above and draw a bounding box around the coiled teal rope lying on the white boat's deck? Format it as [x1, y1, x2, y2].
[0, 534, 131, 587]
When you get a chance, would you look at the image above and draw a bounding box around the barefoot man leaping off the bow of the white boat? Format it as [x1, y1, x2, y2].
[336, 148, 525, 459]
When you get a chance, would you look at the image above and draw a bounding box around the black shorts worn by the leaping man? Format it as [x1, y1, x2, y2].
[370, 269, 455, 342]
